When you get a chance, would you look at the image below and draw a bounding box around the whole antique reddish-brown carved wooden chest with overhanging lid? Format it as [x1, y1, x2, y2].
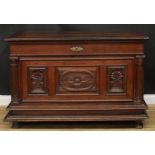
[6, 32, 148, 127]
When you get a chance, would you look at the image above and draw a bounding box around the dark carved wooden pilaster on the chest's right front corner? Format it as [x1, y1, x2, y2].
[135, 55, 145, 103]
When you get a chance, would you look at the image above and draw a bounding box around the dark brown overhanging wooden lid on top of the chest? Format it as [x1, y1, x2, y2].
[5, 31, 149, 41]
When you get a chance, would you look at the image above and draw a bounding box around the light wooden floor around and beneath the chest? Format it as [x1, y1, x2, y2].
[0, 105, 155, 131]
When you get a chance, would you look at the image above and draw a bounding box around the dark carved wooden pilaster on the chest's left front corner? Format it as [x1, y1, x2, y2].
[10, 57, 20, 104]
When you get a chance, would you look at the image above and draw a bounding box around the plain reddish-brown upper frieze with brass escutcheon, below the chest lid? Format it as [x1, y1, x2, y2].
[10, 41, 143, 56]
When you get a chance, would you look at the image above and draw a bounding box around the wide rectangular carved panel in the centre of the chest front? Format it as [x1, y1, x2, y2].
[57, 67, 98, 93]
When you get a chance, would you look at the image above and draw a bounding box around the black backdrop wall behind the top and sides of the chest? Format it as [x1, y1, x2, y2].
[0, 24, 155, 95]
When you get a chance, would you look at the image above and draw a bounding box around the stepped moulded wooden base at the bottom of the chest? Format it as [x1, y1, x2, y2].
[5, 100, 148, 128]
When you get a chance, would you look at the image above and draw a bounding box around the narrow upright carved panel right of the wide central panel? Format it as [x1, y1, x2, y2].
[107, 66, 127, 95]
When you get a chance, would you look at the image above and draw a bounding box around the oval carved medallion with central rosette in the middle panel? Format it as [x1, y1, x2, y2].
[61, 71, 96, 91]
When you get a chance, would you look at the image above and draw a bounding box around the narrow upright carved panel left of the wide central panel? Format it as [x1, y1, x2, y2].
[28, 67, 47, 95]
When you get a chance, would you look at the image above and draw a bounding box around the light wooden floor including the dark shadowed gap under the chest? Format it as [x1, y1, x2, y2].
[0, 104, 155, 131]
